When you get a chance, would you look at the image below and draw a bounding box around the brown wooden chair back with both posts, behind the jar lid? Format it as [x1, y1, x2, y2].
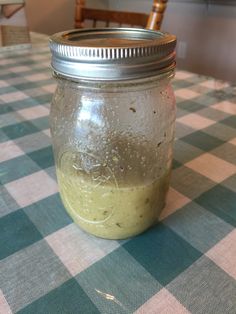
[75, 0, 167, 29]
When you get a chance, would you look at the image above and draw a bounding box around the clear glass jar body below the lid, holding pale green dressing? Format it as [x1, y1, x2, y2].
[50, 73, 175, 239]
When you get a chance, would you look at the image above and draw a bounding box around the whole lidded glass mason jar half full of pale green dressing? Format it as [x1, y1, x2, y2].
[50, 28, 176, 239]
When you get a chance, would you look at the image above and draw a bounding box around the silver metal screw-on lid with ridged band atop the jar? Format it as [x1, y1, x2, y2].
[50, 28, 176, 81]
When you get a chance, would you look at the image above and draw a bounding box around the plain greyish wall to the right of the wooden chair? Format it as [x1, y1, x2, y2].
[163, 3, 236, 82]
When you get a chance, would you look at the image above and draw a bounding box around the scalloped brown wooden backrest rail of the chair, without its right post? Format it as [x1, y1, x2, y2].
[75, 0, 149, 28]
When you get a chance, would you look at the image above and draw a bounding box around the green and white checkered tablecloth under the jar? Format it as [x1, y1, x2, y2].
[0, 39, 236, 314]
